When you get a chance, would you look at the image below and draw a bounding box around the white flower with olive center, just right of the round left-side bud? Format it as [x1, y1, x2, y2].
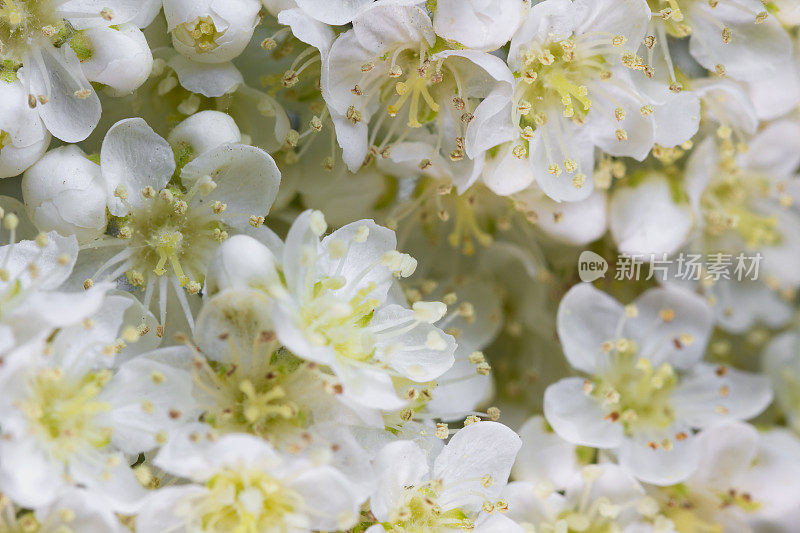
[78, 114, 280, 328]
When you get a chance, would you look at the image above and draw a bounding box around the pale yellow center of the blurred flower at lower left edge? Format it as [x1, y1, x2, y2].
[21, 368, 111, 457]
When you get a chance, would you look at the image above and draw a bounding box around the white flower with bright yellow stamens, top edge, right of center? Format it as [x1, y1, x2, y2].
[490, 0, 700, 201]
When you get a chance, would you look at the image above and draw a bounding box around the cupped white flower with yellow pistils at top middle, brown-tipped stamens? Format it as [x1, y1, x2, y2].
[322, 1, 513, 181]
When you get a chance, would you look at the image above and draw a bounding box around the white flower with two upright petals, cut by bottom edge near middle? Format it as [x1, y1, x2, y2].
[367, 422, 523, 533]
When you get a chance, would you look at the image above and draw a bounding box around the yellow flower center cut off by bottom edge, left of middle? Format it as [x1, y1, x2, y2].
[195, 468, 303, 532]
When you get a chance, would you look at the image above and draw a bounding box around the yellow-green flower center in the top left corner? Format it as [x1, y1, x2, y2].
[0, 0, 70, 63]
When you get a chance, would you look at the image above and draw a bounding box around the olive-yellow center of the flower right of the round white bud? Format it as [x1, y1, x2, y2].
[118, 188, 228, 293]
